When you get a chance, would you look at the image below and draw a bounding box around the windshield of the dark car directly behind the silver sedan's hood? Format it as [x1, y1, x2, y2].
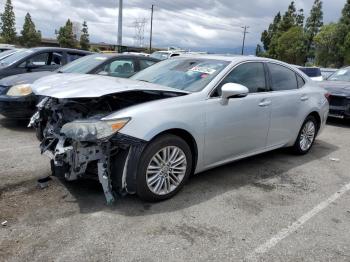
[57, 54, 108, 74]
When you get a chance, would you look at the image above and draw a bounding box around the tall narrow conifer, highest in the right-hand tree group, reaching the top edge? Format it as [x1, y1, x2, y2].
[305, 0, 323, 58]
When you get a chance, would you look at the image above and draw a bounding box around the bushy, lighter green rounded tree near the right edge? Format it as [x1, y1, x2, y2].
[314, 23, 343, 67]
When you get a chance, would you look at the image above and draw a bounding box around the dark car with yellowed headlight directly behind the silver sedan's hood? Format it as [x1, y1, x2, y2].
[0, 54, 160, 119]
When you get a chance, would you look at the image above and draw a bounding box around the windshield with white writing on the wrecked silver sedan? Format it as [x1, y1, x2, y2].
[131, 58, 229, 92]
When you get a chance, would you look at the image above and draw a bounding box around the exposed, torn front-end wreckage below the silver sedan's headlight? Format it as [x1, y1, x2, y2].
[41, 133, 147, 204]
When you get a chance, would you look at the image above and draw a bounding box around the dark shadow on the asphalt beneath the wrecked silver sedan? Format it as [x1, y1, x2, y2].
[62, 140, 338, 216]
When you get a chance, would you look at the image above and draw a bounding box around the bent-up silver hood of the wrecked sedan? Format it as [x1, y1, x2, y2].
[32, 74, 188, 98]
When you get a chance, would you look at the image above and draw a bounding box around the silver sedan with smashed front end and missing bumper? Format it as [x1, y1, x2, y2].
[31, 55, 329, 203]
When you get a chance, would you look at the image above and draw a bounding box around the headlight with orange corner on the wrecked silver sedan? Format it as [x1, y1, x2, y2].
[61, 118, 130, 141]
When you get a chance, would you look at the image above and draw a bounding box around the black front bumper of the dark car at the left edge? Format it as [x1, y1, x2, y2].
[0, 95, 37, 119]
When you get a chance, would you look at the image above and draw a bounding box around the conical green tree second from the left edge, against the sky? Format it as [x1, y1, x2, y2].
[19, 13, 41, 47]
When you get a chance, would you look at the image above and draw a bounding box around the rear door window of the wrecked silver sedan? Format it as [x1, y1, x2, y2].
[268, 63, 298, 91]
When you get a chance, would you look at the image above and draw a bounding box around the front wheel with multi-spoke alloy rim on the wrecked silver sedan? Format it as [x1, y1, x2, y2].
[136, 134, 192, 202]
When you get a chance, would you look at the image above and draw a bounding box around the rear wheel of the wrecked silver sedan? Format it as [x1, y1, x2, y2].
[292, 116, 318, 155]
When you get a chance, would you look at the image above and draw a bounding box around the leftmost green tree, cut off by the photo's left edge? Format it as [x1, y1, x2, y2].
[1, 0, 16, 44]
